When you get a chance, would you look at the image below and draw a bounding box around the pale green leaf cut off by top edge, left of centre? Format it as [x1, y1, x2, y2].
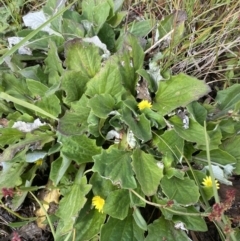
[82, 0, 111, 34]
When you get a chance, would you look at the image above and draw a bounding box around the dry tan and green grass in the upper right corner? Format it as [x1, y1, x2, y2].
[125, 0, 240, 85]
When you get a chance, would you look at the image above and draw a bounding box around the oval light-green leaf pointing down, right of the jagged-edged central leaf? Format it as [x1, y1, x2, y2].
[133, 149, 163, 196]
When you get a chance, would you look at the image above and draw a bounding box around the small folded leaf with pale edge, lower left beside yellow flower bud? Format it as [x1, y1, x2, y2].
[49, 155, 72, 186]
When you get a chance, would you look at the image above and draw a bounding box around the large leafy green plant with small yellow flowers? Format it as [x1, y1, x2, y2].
[0, 0, 240, 241]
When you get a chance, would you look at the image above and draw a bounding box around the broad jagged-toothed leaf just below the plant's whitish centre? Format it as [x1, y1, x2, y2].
[92, 148, 137, 188]
